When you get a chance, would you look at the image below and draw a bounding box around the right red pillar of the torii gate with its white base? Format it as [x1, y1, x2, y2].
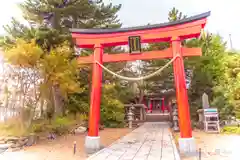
[171, 37, 196, 153]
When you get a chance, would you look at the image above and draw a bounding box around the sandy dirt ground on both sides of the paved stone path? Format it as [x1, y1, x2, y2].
[0, 128, 240, 160]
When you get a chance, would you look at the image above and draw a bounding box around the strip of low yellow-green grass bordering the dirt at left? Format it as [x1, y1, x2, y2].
[0, 115, 86, 137]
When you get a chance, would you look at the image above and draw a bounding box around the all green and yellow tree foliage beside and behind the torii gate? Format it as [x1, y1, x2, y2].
[5, 0, 240, 131]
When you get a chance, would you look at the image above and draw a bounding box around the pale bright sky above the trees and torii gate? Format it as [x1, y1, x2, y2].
[0, 0, 240, 50]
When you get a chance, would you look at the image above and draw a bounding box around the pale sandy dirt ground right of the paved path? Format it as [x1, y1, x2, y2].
[182, 131, 240, 160]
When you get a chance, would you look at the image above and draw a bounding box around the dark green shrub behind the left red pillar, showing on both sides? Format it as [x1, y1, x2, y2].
[66, 84, 126, 128]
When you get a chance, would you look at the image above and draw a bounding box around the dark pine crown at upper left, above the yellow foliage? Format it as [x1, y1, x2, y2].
[0, 0, 121, 51]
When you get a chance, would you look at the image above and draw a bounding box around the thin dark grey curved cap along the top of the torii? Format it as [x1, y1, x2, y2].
[70, 11, 211, 34]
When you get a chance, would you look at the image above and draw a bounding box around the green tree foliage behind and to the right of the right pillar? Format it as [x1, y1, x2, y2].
[143, 8, 240, 119]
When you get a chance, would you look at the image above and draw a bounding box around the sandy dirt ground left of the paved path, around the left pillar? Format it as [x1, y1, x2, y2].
[0, 128, 132, 160]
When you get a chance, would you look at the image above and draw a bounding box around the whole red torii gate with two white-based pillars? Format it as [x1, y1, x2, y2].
[71, 12, 210, 152]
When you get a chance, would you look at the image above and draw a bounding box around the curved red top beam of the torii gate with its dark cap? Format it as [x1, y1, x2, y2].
[71, 12, 210, 48]
